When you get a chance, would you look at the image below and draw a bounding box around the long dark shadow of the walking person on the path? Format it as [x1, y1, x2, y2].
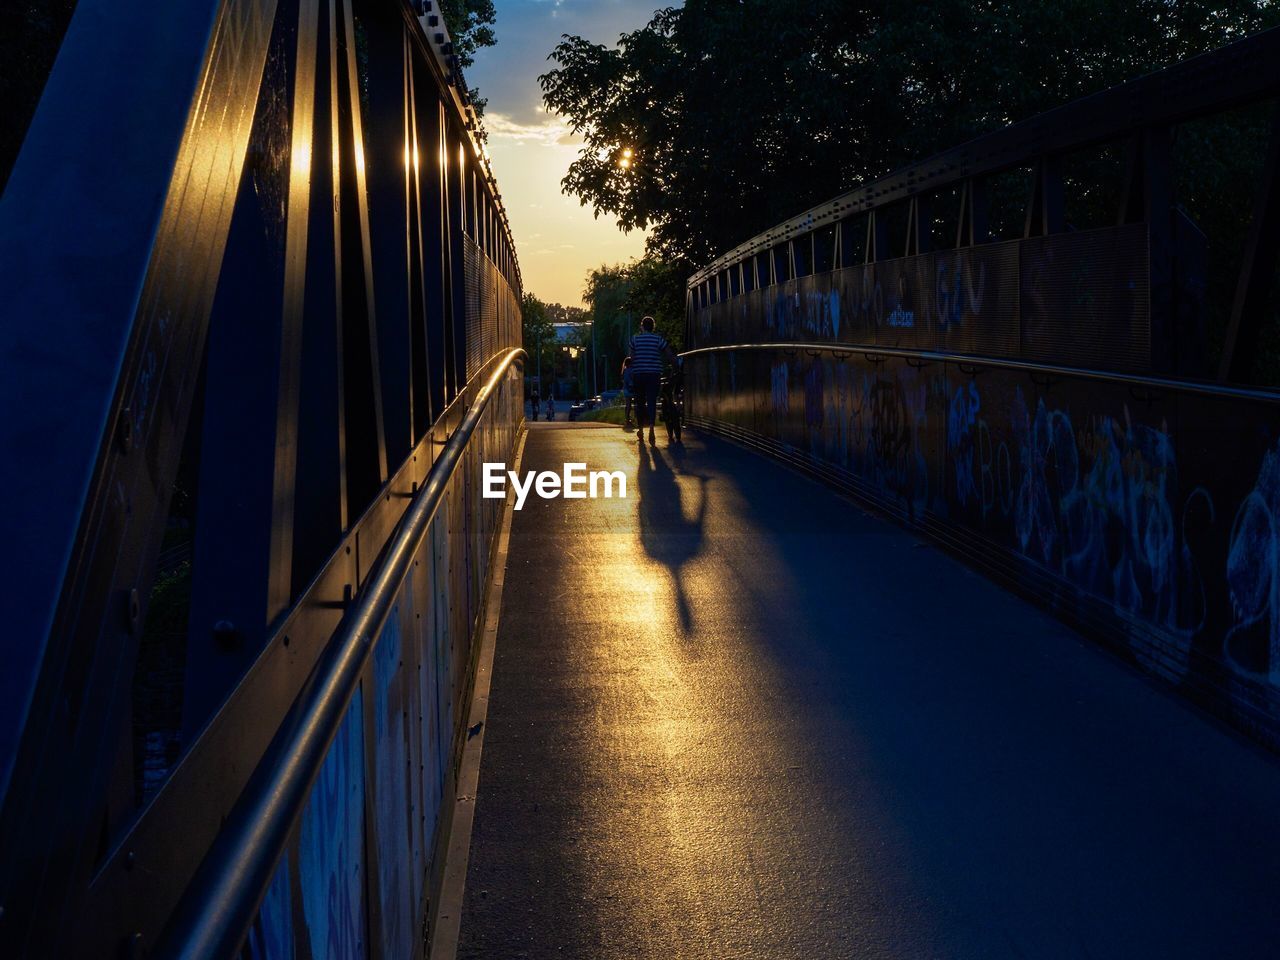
[636, 444, 708, 634]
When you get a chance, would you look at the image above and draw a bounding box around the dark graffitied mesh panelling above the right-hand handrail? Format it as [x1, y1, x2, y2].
[689, 224, 1151, 370]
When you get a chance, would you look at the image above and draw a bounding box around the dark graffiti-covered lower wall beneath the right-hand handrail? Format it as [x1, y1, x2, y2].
[686, 346, 1280, 748]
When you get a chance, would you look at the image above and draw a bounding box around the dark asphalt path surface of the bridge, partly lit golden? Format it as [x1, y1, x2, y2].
[460, 424, 1280, 960]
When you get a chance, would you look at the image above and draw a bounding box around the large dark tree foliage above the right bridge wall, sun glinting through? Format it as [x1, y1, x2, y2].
[540, 0, 1277, 264]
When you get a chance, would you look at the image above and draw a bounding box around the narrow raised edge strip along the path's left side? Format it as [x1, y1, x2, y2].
[426, 430, 529, 960]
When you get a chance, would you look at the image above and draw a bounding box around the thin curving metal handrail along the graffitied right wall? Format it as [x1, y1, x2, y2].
[680, 340, 1280, 403]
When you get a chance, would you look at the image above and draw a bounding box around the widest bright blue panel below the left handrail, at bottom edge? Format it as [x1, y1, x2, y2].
[298, 690, 366, 960]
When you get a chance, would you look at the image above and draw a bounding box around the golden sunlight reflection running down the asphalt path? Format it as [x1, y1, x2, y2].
[496, 426, 880, 957]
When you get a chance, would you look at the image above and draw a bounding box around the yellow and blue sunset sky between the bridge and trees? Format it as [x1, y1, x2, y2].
[466, 0, 677, 306]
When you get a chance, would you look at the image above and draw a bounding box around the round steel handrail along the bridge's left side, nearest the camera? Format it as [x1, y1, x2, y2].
[156, 347, 525, 960]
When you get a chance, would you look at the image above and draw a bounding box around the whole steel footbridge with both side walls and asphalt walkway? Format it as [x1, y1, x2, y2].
[0, 0, 1280, 957]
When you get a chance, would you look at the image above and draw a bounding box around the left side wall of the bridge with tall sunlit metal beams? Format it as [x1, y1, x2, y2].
[0, 0, 522, 957]
